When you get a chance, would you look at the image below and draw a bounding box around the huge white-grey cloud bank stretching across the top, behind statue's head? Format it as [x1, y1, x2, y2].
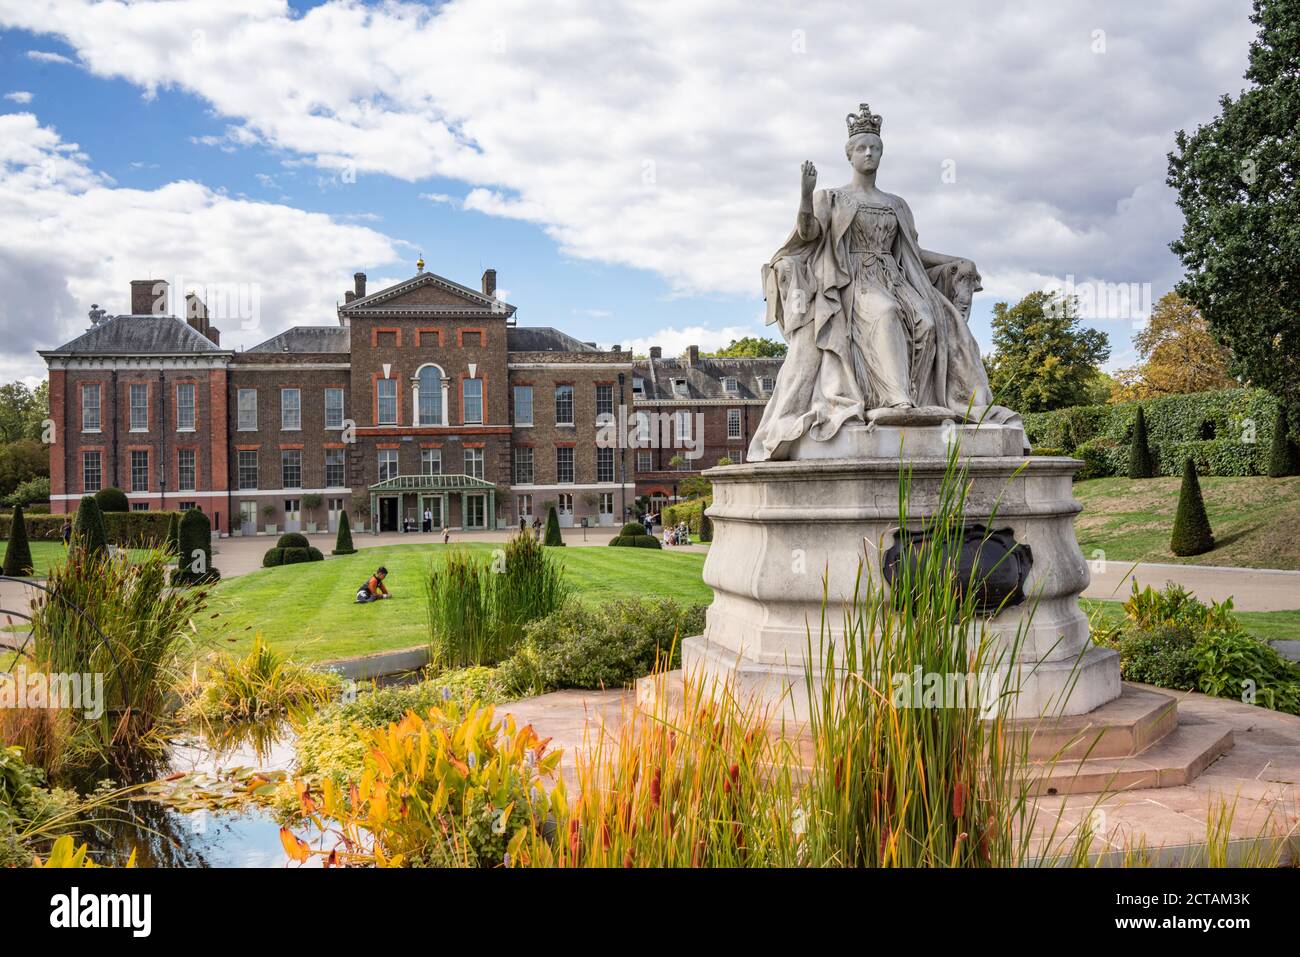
[0, 0, 1253, 312]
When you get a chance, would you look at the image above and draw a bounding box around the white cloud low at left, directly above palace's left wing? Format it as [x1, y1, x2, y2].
[0, 113, 399, 380]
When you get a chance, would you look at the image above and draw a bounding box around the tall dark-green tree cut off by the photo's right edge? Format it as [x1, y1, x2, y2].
[1169, 0, 1300, 417]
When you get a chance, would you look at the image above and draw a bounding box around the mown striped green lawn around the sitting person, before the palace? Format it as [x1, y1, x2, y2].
[199, 542, 712, 662]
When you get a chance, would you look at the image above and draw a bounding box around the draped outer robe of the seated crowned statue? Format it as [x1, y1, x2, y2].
[749, 190, 1019, 462]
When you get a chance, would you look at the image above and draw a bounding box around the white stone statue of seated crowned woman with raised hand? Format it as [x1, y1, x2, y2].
[749, 103, 1019, 462]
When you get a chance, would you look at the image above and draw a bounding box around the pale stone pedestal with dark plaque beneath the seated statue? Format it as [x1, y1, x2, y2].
[681, 424, 1119, 720]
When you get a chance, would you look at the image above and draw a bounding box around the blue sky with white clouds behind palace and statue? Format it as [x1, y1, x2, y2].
[0, 0, 1255, 384]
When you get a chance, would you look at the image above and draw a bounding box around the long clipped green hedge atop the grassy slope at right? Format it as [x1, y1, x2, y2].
[1024, 389, 1278, 475]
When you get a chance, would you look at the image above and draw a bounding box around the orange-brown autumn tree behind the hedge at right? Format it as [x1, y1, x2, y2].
[1110, 293, 1238, 402]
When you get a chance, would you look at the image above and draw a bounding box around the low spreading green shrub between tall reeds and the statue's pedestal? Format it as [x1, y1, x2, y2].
[501, 598, 705, 694]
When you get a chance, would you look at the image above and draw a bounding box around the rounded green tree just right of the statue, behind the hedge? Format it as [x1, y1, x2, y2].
[988, 291, 1110, 412]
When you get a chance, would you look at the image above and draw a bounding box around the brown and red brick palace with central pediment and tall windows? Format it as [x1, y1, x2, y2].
[40, 263, 781, 534]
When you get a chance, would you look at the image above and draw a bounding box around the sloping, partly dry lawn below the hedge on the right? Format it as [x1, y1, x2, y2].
[1074, 476, 1300, 570]
